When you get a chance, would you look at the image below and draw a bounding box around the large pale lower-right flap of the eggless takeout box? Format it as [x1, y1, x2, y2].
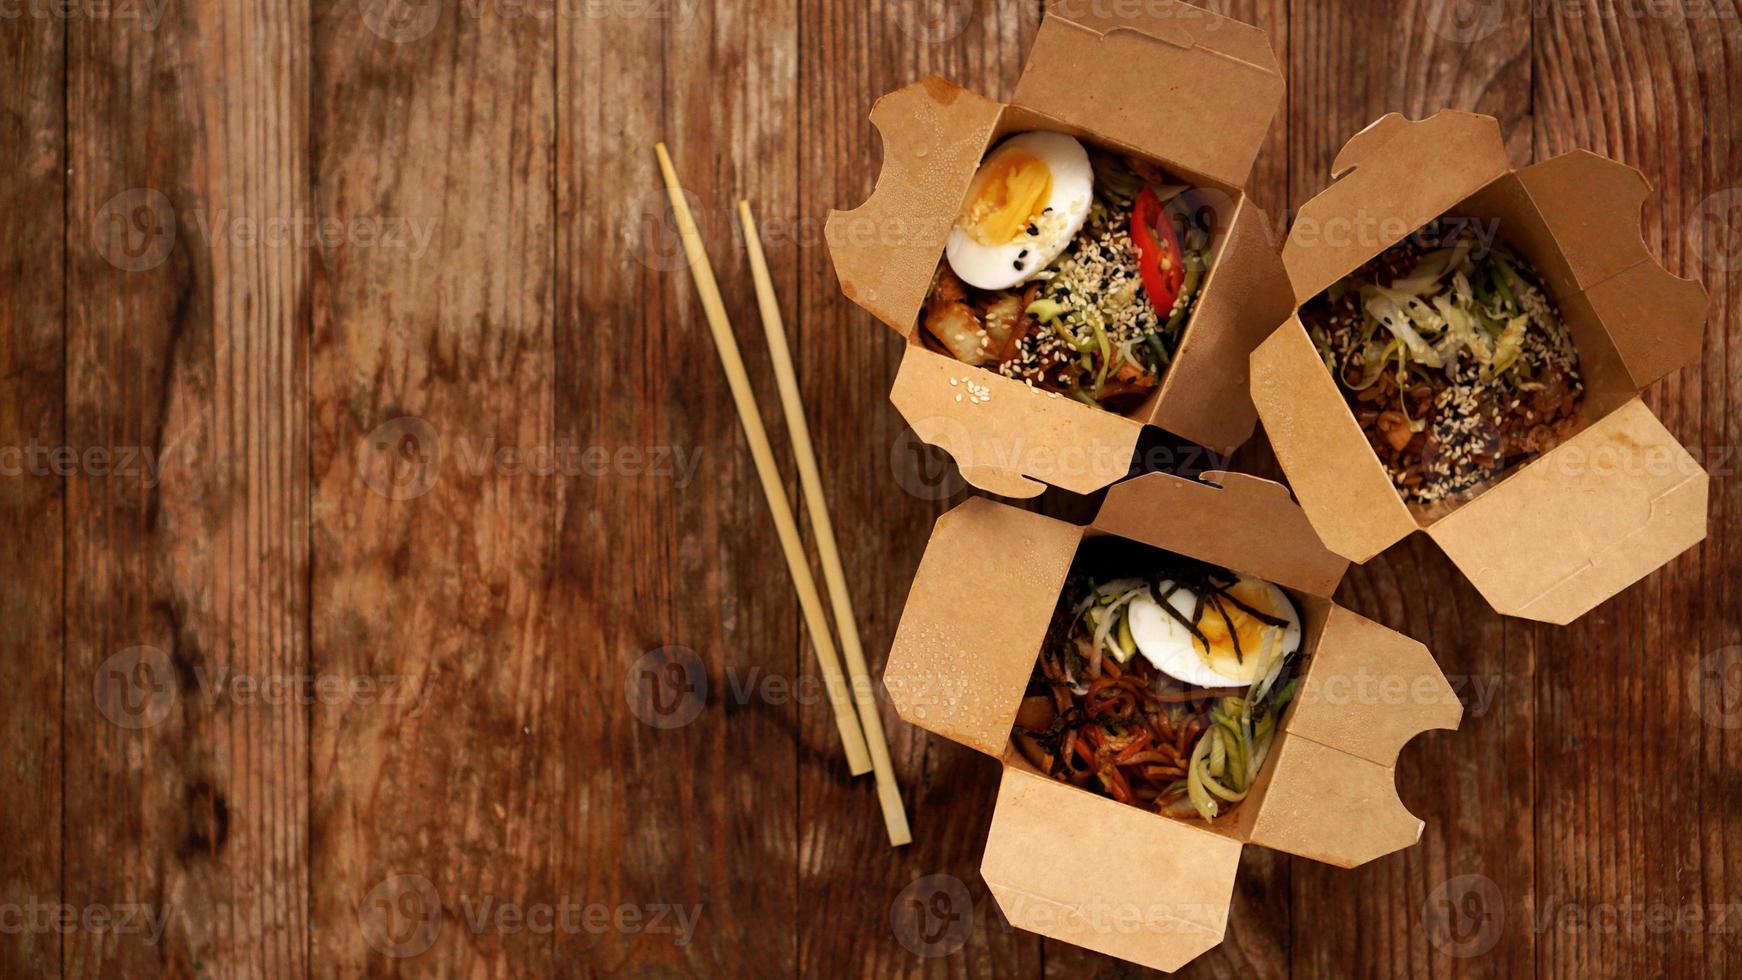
[1428, 399, 1709, 623]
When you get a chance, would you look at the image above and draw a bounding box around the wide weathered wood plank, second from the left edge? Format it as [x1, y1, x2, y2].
[63, 3, 308, 977]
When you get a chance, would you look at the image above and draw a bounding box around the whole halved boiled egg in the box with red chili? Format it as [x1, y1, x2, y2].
[944, 132, 1094, 289]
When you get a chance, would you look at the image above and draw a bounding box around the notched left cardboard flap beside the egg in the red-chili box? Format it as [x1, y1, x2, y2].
[824, 75, 1003, 336]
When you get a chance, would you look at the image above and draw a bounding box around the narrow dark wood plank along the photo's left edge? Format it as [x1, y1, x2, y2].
[0, 9, 66, 977]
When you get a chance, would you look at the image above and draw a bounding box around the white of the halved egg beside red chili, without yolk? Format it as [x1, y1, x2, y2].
[944, 132, 1094, 289]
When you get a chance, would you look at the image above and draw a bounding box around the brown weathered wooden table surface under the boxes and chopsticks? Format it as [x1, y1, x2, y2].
[0, 0, 1742, 977]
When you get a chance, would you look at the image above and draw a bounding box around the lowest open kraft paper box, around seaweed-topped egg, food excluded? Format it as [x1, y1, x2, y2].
[883, 473, 1463, 970]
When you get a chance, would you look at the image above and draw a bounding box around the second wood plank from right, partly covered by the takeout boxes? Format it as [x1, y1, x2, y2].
[1289, 2, 1535, 977]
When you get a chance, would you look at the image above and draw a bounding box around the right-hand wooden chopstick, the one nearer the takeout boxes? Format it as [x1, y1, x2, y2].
[739, 200, 913, 848]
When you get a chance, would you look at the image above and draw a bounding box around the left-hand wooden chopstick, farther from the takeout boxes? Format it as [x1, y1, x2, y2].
[653, 143, 871, 776]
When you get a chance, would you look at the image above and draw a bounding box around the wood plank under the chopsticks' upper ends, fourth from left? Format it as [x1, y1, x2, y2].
[552, 2, 801, 977]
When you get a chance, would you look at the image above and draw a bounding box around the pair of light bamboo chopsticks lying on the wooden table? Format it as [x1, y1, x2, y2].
[653, 143, 913, 846]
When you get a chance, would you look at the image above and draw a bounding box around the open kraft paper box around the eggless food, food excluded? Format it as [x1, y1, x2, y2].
[1251, 110, 1707, 623]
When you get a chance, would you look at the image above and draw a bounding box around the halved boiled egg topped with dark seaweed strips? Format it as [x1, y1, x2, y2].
[1129, 574, 1301, 688]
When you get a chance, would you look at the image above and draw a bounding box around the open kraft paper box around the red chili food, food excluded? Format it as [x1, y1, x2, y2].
[827, 0, 1291, 496]
